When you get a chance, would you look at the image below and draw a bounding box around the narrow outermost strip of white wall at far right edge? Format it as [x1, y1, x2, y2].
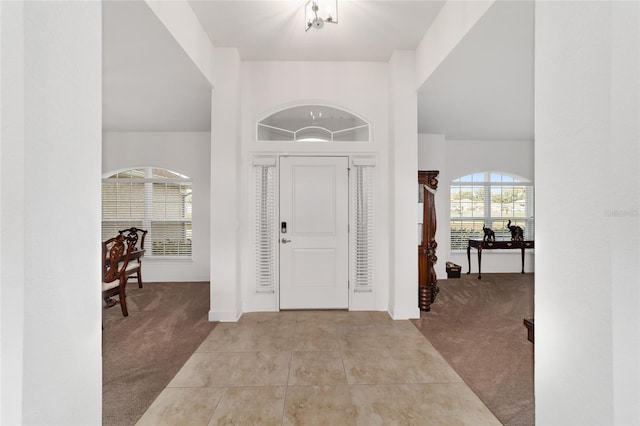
[605, 2, 640, 425]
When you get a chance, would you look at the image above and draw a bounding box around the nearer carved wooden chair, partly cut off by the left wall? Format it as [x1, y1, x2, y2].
[102, 235, 132, 317]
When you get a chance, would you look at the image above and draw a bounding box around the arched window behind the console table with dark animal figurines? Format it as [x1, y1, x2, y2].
[450, 172, 534, 250]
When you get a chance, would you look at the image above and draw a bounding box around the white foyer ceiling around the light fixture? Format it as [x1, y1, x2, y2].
[189, 0, 444, 62]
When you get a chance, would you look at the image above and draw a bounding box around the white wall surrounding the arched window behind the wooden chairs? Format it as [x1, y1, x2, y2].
[102, 132, 211, 282]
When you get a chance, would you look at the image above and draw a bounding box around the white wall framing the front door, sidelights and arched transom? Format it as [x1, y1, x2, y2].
[240, 61, 392, 311]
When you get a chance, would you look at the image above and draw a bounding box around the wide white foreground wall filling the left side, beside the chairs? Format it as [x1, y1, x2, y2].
[1, 1, 102, 425]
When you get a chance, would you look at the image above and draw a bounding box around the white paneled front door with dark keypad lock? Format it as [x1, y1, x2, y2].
[280, 157, 349, 309]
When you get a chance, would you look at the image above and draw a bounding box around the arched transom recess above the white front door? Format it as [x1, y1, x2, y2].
[257, 105, 370, 142]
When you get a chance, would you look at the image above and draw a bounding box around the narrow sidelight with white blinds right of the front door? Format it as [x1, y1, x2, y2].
[353, 159, 375, 292]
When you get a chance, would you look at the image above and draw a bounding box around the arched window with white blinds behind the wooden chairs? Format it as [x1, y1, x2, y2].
[102, 167, 193, 259]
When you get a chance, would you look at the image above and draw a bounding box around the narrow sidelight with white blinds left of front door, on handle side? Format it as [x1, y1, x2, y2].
[254, 158, 277, 293]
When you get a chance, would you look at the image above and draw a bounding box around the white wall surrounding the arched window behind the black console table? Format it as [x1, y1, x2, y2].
[418, 135, 535, 278]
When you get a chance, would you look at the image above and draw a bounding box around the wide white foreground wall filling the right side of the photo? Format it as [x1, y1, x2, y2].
[535, 1, 640, 425]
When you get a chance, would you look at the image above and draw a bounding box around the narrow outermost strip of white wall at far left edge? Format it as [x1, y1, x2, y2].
[0, 2, 25, 425]
